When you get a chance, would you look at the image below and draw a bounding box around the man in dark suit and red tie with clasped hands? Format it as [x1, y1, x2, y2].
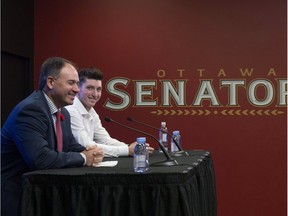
[1, 57, 103, 216]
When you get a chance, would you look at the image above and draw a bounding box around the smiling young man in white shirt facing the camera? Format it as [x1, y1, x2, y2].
[65, 68, 154, 157]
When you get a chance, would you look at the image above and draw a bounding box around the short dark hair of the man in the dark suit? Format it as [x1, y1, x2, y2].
[38, 57, 77, 90]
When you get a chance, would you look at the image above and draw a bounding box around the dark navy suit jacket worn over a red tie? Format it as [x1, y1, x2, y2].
[1, 91, 85, 216]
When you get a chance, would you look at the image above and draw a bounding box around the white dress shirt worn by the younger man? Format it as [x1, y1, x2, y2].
[65, 97, 129, 157]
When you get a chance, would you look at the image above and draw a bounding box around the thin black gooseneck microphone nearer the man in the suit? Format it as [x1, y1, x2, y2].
[105, 117, 178, 166]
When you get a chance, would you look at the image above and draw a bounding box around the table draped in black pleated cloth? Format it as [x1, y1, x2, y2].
[21, 150, 217, 216]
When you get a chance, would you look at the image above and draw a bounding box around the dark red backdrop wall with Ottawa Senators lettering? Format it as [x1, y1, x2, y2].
[34, 0, 287, 216]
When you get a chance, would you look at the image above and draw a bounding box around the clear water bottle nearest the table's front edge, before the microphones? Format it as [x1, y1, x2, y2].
[133, 137, 149, 173]
